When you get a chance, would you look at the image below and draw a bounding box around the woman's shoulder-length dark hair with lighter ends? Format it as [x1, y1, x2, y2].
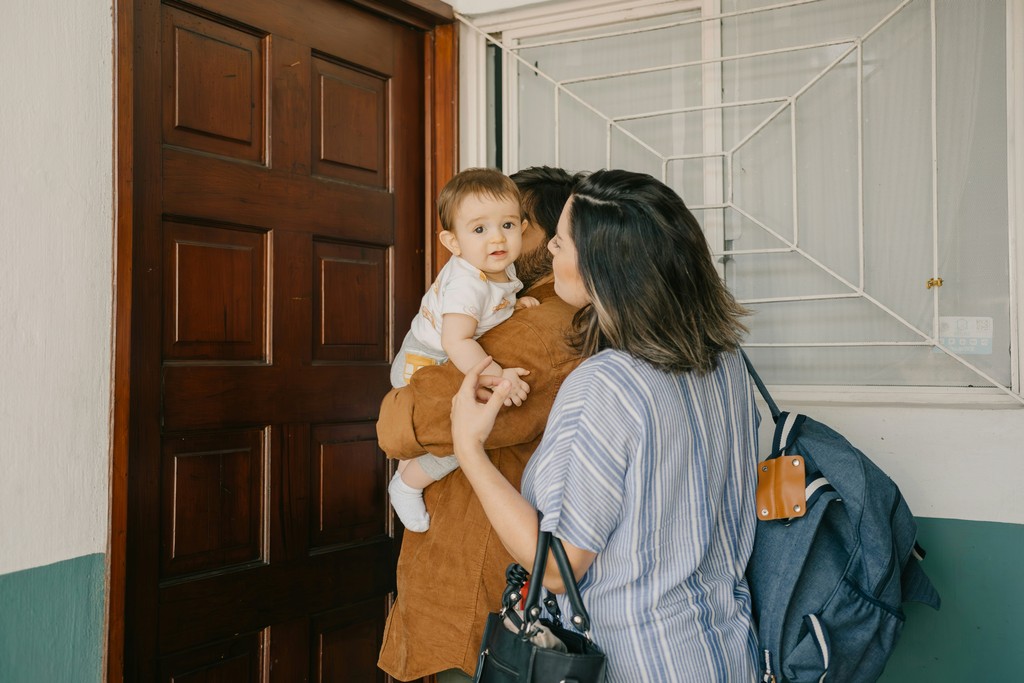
[568, 170, 749, 373]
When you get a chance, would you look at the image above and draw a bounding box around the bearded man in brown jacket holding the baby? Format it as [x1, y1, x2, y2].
[377, 167, 581, 683]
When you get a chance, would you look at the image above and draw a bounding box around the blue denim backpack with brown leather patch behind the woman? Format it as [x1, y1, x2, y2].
[743, 354, 940, 683]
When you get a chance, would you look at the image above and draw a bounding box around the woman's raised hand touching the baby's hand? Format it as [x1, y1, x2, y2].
[452, 355, 512, 458]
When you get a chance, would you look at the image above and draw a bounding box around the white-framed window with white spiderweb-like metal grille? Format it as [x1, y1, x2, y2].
[459, 0, 1024, 403]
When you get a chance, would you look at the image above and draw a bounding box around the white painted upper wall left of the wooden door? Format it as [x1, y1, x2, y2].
[0, 0, 114, 573]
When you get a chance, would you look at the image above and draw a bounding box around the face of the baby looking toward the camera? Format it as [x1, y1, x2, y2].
[452, 195, 522, 282]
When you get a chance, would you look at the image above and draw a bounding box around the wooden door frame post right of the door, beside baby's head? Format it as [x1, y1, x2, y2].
[424, 24, 459, 280]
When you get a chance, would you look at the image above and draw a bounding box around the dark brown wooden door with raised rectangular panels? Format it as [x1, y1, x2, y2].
[124, 0, 442, 683]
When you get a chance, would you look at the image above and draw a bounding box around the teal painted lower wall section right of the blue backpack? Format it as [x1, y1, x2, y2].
[881, 518, 1024, 683]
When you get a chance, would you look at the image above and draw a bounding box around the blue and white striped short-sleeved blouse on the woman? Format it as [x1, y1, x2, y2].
[522, 350, 760, 683]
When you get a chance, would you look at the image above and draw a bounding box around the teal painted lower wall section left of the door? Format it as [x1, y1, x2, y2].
[0, 553, 105, 683]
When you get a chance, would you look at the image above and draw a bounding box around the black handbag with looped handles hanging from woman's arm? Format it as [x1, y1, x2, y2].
[473, 520, 605, 683]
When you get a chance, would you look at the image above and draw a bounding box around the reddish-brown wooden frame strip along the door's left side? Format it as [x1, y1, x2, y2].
[103, 0, 135, 683]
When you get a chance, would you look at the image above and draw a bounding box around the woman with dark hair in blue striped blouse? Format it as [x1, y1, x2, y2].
[452, 171, 758, 683]
